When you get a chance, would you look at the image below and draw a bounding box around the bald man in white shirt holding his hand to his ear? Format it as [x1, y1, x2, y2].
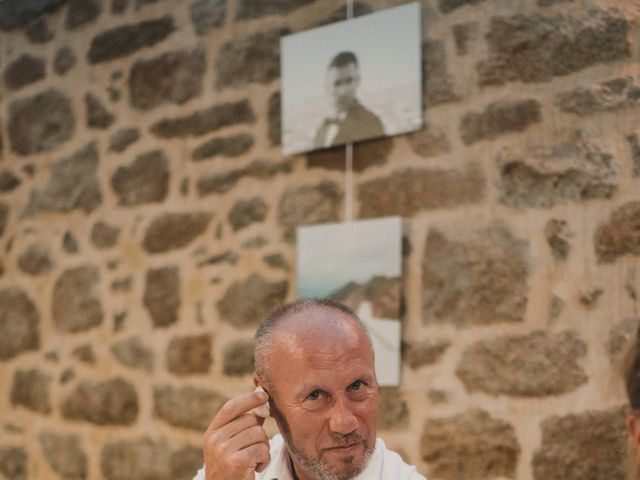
[194, 300, 425, 480]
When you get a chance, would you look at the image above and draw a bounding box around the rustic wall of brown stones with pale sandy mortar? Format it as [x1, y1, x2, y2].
[0, 0, 640, 480]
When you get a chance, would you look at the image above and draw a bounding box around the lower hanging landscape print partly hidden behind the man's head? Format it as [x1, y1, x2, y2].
[297, 217, 402, 386]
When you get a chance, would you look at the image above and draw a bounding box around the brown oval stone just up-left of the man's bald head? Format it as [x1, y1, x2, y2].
[217, 273, 289, 328]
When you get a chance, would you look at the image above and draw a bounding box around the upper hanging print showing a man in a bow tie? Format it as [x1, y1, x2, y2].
[280, 2, 422, 154]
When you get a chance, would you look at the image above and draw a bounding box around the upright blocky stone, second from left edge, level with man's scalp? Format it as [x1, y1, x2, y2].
[52, 265, 104, 333]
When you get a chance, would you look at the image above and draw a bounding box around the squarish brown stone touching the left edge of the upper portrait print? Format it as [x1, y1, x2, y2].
[214, 27, 289, 89]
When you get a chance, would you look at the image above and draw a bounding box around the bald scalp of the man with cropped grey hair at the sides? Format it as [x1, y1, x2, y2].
[254, 299, 373, 390]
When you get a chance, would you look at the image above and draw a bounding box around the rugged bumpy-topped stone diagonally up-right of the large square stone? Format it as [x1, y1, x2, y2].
[496, 132, 618, 208]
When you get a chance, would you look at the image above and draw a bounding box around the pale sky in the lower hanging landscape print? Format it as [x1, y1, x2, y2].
[297, 217, 402, 298]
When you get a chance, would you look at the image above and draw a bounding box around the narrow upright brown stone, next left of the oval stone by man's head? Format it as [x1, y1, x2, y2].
[143, 267, 181, 327]
